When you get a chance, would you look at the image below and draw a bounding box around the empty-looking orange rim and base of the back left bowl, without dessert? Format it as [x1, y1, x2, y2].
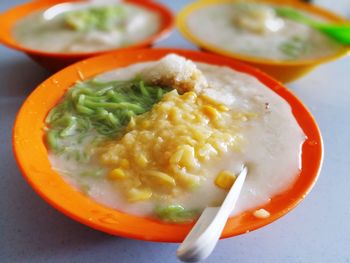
[0, 0, 174, 72]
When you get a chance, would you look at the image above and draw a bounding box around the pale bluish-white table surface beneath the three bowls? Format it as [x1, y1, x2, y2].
[0, 0, 350, 263]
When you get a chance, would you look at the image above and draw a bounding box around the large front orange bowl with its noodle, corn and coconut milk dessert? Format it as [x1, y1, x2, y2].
[13, 49, 322, 242]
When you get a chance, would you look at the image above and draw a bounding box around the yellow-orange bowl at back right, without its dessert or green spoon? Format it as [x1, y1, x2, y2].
[176, 0, 350, 83]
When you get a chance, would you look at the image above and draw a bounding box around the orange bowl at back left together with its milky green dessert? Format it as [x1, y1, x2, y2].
[0, 0, 173, 71]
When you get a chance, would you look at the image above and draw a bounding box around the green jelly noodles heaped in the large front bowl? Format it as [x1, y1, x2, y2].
[45, 78, 171, 154]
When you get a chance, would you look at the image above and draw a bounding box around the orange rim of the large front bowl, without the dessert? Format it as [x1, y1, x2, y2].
[13, 49, 323, 242]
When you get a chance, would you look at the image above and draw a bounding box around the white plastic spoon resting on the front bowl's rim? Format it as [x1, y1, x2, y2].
[176, 166, 248, 262]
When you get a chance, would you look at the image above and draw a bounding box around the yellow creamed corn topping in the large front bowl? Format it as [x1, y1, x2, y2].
[98, 90, 252, 202]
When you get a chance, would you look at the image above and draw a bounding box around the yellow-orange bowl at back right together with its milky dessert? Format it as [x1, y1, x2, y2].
[177, 0, 349, 82]
